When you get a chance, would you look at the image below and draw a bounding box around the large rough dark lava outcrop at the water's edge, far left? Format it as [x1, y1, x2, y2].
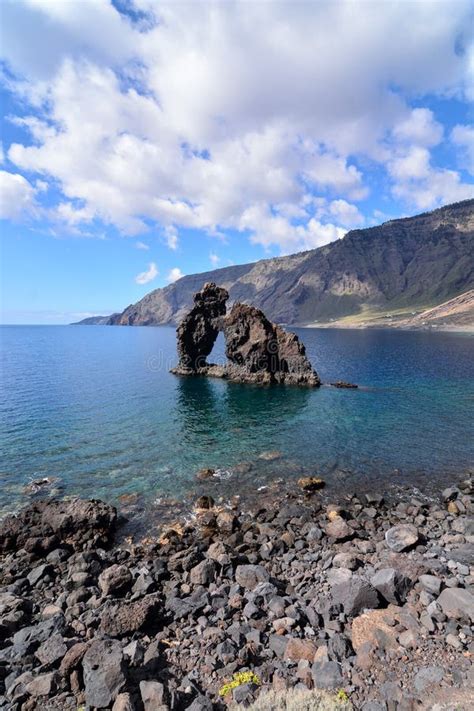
[0, 499, 117, 555]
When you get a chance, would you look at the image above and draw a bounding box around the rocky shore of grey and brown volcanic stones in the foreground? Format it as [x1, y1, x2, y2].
[0, 478, 474, 711]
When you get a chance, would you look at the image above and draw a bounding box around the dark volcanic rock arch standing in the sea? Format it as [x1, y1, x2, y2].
[172, 283, 320, 387]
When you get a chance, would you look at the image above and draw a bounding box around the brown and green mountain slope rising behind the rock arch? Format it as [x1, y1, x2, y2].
[109, 200, 474, 325]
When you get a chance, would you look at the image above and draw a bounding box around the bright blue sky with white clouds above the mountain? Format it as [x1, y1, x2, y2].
[0, 0, 474, 324]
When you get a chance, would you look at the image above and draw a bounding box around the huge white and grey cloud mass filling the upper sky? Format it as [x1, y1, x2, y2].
[2, 0, 470, 252]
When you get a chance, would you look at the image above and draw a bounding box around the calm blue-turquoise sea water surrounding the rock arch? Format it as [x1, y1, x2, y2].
[0, 326, 474, 511]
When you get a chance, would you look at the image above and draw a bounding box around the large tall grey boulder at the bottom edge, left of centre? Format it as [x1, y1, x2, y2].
[82, 639, 125, 708]
